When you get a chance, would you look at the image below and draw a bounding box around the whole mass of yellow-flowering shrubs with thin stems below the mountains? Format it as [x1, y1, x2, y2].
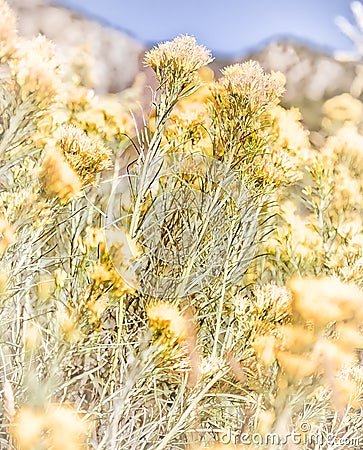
[0, 0, 363, 450]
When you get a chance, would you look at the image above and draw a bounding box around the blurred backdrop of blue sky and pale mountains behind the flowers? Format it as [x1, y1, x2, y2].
[9, 0, 363, 128]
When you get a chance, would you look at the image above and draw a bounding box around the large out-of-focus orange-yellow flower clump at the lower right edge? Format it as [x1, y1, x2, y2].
[253, 277, 363, 409]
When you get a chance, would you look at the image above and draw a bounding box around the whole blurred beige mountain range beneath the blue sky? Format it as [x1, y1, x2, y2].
[9, 0, 362, 127]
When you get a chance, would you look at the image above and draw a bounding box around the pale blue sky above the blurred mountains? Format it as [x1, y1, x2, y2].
[55, 0, 354, 56]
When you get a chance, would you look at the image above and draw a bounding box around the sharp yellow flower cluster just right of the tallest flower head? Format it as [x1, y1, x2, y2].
[210, 61, 285, 156]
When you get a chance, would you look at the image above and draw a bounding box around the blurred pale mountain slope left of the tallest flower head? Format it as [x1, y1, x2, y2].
[8, 0, 143, 93]
